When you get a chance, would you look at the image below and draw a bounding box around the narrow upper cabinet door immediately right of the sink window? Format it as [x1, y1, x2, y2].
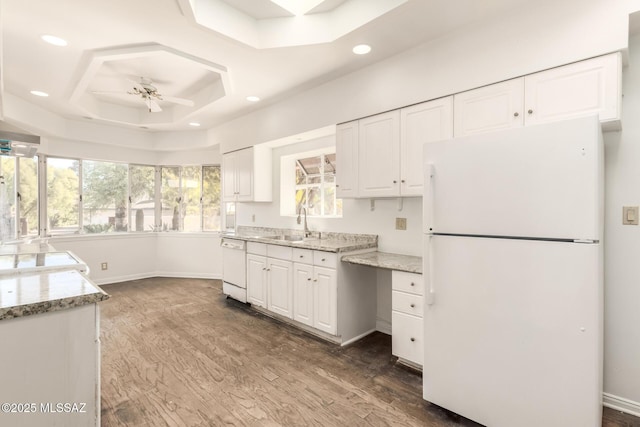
[336, 121, 358, 198]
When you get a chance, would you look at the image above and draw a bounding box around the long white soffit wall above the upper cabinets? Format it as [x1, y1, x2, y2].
[214, 0, 628, 153]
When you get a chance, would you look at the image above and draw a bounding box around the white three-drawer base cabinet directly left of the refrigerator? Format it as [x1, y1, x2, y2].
[391, 270, 424, 366]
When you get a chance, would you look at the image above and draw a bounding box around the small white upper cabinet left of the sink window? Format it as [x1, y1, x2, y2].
[222, 146, 272, 202]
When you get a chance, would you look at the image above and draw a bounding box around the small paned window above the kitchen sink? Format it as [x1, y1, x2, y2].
[295, 153, 342, 216]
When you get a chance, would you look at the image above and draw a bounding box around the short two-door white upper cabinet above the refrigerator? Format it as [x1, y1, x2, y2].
[454, 53, 622, 137]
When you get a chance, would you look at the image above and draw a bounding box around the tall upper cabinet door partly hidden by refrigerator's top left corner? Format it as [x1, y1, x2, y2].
[400, 96, 453, 196]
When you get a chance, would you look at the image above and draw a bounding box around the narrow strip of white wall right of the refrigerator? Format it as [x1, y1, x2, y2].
[604, 35, 640, 416]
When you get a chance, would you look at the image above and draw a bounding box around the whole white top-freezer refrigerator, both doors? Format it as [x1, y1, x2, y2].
[423, 116, 604, 427]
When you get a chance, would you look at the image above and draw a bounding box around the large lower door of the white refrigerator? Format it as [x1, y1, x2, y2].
[423, 236, 602, 427]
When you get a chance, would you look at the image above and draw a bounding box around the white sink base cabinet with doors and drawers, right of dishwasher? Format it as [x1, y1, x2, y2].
[247, 242, 377, 345]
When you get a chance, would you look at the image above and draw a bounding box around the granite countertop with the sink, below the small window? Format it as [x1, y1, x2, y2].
[221, 226, 378, 252]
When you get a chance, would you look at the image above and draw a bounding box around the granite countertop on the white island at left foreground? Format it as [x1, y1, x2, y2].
[0, 270, 109, 320]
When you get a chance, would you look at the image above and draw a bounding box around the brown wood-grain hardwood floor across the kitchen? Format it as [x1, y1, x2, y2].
[100, 278, 640, 427]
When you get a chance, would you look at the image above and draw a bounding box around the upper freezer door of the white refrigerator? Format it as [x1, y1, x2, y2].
[423, 116, 604, 240]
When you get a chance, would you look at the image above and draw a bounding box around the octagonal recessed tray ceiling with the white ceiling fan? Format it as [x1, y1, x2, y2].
[70, 43, 229, 127]
